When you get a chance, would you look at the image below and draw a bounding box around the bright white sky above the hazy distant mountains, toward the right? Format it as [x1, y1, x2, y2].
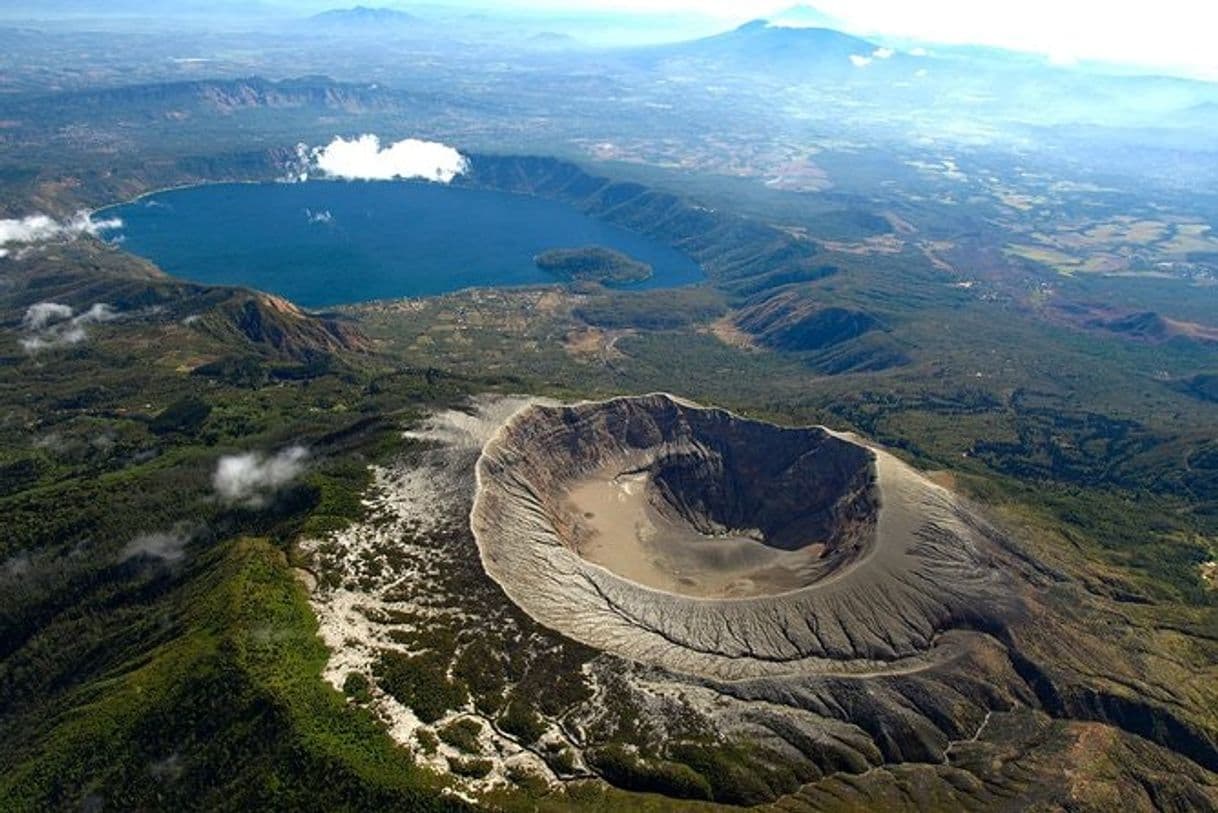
[433, 0, 1218, 80]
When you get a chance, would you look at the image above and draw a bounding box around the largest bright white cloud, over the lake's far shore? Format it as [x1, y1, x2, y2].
[306, 133, 469, 184]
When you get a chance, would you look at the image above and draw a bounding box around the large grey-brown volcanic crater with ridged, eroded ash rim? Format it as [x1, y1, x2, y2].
[470, 394, 1009, 679]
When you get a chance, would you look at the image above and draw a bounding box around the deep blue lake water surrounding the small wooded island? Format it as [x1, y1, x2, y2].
[101, 182, 703, 308]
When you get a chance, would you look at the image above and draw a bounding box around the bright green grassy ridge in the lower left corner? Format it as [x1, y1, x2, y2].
[0, 539, 460, 809]
